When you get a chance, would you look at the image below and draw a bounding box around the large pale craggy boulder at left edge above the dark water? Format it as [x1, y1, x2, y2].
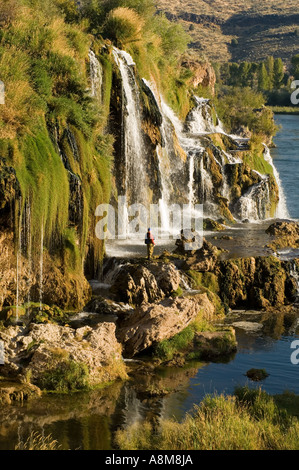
[0, 322, 126, 385]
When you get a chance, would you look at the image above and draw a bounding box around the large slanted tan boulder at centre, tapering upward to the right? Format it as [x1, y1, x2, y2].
[116, 293, 215, 357]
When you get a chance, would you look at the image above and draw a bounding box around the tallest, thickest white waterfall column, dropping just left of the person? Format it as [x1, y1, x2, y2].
[113, 48, 147, 213]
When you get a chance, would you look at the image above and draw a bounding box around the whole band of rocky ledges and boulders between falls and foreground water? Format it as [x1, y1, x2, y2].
[0, 222, 298, 404]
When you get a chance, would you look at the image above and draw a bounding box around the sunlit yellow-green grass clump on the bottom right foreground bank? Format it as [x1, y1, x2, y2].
[116, 388, 299, 450]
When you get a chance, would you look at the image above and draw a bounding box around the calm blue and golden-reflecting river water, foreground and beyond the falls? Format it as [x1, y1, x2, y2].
[0, 115, 299, 450]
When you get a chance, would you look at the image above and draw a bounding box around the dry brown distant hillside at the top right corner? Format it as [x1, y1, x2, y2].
[156, 0, 299, 62]
